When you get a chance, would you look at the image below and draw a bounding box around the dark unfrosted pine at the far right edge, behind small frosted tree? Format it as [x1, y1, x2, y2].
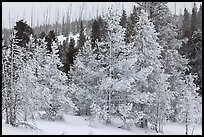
[179, 3, 202, 95]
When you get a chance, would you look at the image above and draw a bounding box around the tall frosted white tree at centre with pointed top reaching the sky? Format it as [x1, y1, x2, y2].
[89, 8, 135, 124]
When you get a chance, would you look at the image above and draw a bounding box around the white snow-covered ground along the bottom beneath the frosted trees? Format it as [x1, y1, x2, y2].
[2, 115, 202, 135]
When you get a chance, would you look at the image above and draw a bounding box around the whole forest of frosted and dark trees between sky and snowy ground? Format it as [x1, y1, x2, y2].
[2, 2, 202, 134]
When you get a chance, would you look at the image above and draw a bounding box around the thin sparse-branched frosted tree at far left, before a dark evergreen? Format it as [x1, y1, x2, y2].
[5, 30, 26, 126]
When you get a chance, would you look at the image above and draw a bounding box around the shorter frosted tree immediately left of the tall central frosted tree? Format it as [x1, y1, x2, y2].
[69, 31, 98, 115]
